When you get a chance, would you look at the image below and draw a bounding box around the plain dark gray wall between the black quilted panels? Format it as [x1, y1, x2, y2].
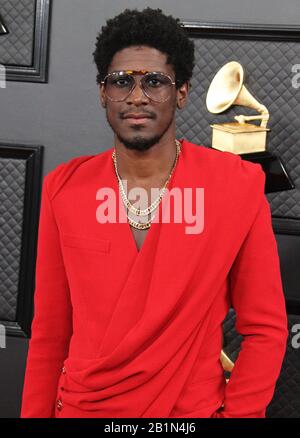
[0, 0, 300, 418]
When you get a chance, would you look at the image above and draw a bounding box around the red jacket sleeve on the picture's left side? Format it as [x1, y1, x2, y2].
[20, 175, 72, 418]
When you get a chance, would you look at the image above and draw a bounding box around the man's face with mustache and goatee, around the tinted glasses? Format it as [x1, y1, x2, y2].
[100, 46, 188, 151]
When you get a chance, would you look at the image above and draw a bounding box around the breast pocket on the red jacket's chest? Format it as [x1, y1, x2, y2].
[61, 233, 110, 253]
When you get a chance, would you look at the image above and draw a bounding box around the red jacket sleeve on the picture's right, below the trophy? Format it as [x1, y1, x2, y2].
[213, 171, 288, 418]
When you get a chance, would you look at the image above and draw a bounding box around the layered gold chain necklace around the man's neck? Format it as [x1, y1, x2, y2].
[112, 139, 181, 230]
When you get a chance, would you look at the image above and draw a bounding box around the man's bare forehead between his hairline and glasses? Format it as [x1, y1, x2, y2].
[108, 46, 174, 74]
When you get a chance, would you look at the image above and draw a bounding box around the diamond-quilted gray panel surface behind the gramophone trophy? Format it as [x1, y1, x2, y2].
[177, 38, 300, 219]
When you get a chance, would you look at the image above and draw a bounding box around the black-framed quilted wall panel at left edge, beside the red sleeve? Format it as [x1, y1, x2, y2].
[0, 143, 43, 337]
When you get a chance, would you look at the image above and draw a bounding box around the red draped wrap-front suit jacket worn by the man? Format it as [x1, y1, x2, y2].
[21, 140, 288, 418]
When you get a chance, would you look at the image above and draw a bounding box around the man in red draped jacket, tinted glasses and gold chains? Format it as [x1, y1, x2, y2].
[21, 8, 288, 418]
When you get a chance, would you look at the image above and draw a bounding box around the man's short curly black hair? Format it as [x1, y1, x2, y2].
[93, 7, 195, 88]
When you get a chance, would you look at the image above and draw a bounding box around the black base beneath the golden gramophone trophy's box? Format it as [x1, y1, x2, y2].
[239, 151, 295, 193]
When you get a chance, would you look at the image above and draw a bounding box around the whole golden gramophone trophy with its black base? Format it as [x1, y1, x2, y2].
[206, 61, 295, 192]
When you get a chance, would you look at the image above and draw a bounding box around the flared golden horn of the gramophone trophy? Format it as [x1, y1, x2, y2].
[206, 61, 269, 128]
